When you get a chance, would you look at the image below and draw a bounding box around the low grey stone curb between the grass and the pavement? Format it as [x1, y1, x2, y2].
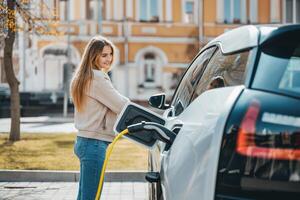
[0, 170, 146, 182]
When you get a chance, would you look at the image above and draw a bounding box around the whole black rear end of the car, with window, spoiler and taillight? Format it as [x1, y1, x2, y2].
[215, 25, 300, 200]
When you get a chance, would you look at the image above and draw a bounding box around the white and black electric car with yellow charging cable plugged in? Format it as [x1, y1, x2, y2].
[116, 24, 300, 200]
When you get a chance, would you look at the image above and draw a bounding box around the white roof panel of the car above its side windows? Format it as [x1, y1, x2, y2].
[203, 25, 279, 54]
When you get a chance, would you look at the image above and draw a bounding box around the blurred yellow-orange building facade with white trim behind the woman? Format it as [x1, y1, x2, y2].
[15, 0, 300, 101]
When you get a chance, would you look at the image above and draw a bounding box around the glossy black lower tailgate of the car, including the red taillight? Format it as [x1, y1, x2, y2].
[215, 89, 300, 200]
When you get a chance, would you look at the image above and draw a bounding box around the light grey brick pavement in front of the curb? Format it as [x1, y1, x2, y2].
[0, 182, 148, 200]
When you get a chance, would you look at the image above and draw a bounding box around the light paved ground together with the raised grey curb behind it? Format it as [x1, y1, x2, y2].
[0, 170, 149, 200]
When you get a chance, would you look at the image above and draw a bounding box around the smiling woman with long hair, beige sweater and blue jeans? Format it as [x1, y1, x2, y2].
[71, 36, 129, 200]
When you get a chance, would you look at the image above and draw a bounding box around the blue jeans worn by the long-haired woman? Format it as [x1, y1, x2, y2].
[74, 136, 109, 200]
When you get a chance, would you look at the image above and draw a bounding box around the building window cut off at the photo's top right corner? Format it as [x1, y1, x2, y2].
[285, 0, 300, 23]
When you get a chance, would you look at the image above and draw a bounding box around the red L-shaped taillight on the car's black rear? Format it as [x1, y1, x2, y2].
[236, 100, 300, 160]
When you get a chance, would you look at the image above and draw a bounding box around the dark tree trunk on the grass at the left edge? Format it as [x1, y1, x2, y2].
[4, 0, 20, 141]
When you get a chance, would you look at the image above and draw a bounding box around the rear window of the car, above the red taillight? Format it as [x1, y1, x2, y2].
[252, 39, 300, 97]
